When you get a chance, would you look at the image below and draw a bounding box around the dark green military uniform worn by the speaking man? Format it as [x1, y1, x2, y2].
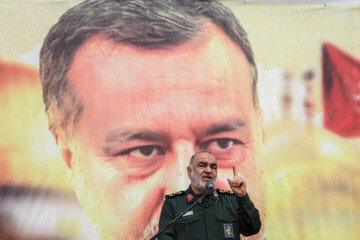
[158, 186, 261, 240]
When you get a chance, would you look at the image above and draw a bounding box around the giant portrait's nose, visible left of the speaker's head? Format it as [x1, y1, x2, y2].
[166, 140, 195, 192]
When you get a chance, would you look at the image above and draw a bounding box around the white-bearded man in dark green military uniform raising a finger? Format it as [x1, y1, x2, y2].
[158, 151, 261, 240]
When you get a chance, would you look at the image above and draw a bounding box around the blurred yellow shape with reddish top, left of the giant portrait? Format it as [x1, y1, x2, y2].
[0, 61, 71, 190]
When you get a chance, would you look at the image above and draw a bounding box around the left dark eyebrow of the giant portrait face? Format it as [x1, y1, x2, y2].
[105, 129, 170, 143]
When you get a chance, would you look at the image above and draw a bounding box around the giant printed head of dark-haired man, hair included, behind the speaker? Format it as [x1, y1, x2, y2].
[40, 0, 265, 239]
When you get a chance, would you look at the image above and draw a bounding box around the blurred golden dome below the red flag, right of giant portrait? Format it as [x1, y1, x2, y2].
[265, 124, 360, 240]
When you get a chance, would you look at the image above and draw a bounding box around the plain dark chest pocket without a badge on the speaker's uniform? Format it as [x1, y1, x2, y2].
[175, 216, 202, 240]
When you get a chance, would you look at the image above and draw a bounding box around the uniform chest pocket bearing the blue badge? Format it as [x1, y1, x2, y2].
[216, 214, 240, 239]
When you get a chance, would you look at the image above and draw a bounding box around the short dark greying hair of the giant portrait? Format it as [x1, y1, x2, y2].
[40, 0, 258, 142]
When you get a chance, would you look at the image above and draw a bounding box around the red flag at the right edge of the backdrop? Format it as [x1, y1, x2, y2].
[322, 43, 360, 137]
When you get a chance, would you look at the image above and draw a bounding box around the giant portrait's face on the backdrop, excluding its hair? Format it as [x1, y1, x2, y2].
[64, 23, 265, 239]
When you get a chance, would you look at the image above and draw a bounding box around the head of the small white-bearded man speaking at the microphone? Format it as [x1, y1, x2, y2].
[187, 152, 217, 194]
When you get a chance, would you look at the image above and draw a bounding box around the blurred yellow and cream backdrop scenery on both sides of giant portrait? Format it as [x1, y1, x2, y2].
[0, 0, 360, 240]
